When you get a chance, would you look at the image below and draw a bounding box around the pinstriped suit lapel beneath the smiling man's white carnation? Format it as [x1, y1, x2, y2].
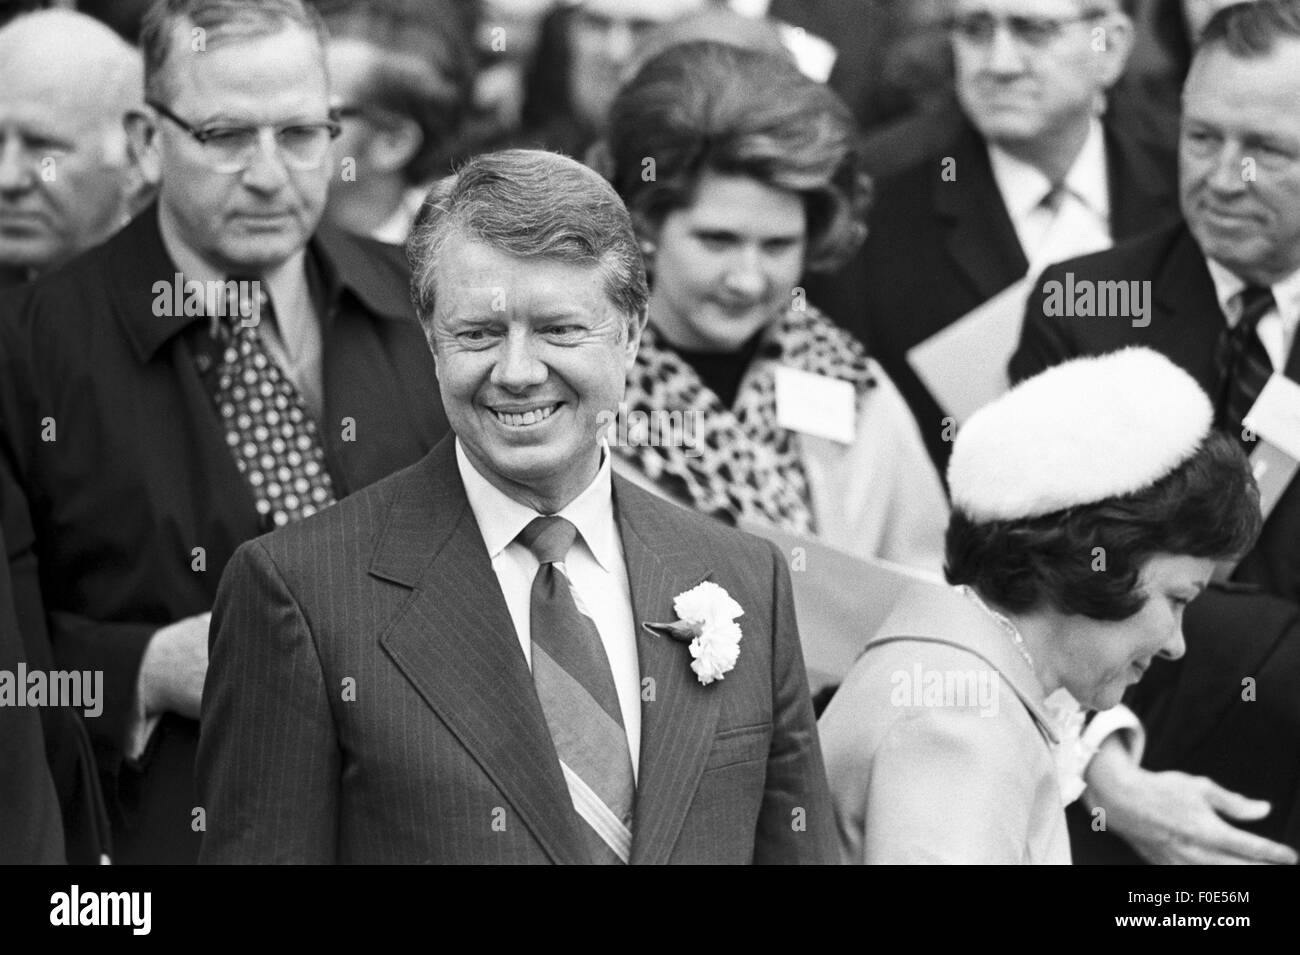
[614, 477, 723, 865]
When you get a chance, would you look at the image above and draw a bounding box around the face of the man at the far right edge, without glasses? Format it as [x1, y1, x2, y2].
[1179, 39, 1300, 285]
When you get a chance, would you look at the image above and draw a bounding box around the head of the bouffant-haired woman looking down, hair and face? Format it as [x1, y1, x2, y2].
[608, 42, 870, 351]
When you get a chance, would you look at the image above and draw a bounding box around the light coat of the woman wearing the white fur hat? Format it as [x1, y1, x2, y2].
[820, 583, 1070, 864]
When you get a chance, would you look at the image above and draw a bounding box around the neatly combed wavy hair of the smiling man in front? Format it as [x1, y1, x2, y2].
[406, 149, 650, 344]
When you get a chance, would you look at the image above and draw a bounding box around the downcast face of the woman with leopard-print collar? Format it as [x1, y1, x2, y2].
[649, 172, 807, 352]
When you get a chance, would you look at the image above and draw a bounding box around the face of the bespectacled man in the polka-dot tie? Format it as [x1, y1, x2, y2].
[141, 23, 333, 273]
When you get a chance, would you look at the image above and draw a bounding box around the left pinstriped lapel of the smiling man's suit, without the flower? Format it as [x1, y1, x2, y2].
[371, 438, 589, 863]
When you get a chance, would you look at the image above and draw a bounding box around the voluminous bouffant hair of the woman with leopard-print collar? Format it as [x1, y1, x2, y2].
[606, 40, 871, 269]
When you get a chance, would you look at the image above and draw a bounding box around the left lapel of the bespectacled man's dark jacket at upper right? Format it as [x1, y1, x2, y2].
[933, 129, 1030, 301]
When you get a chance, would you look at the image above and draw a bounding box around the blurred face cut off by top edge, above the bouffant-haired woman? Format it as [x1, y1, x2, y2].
[568, 0, 705, 126]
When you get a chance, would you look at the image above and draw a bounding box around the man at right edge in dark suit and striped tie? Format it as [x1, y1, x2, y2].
[1010, 0, 1300, 860]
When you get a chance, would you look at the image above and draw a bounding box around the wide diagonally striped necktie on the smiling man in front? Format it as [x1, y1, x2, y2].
[519, 517, 636, 865]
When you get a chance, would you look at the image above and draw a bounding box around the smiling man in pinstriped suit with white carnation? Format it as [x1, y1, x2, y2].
[198, 151, 836, 864]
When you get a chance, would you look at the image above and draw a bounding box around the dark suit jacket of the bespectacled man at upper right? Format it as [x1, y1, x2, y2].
[806, 122, 1178, 472]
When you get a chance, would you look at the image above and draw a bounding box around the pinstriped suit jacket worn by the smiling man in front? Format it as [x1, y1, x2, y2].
[198, 437, 836, 863]
